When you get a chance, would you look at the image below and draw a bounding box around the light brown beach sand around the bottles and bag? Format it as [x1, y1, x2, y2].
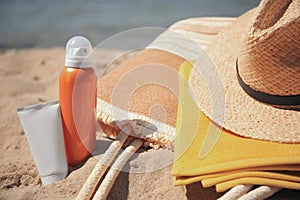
[0, 48, 299, 200]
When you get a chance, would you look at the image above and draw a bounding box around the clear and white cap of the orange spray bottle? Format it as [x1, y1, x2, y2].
[65, 36, 93, 68]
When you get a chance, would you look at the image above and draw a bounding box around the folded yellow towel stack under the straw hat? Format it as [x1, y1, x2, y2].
[172, 62, 300, 191]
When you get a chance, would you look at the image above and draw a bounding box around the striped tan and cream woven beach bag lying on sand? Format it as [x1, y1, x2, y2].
[97, 18, 235, 149]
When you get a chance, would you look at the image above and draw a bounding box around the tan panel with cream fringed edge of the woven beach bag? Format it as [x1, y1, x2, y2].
[97, 49, 184, 148]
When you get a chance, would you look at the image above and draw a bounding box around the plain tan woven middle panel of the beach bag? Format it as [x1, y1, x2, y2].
[99, 49, 184, 127]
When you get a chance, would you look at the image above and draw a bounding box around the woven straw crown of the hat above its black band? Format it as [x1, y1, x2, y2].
[238, 0, 300, 96]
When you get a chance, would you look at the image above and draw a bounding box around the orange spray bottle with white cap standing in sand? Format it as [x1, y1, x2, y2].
[59, 36, 97, 166]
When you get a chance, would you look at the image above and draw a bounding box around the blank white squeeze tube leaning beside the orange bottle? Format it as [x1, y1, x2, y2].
[17, 101, 68, 185]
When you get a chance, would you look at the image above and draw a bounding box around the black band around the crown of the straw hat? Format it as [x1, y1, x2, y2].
[236, 59, 300, 106]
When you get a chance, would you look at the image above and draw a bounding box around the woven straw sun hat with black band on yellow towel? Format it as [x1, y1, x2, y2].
[189, 0, 300, 143]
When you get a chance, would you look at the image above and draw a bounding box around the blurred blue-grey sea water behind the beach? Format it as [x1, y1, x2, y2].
[0, 0, 259, 49]
